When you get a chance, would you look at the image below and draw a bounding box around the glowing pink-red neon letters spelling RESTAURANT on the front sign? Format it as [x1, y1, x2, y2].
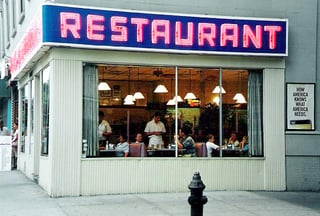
[60, 12, 282, 49]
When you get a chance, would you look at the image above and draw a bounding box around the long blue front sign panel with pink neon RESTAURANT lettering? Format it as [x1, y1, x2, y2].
[43, 5, 288, 56]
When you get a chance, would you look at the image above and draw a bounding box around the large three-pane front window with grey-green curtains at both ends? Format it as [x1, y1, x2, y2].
[83, 64, 263, 157]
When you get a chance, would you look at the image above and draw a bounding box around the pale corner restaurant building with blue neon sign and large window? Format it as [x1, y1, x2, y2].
[1, 0, 320, 197]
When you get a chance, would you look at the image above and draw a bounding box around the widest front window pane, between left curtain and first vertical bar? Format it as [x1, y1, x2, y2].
[97, 65, 175, 156]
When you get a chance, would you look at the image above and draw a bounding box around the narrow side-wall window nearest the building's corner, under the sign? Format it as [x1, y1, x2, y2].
[41, 68, 50, 155]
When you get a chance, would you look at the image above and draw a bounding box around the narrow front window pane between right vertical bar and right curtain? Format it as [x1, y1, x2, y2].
[222, 69, 248, 157]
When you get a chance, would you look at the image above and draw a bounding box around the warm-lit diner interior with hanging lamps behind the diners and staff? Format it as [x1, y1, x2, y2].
[83, 64, 249, 156]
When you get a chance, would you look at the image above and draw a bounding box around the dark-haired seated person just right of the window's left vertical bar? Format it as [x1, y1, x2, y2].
[177, 126, 196, 157]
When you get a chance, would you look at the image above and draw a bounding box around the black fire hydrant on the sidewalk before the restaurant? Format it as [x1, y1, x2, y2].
[188, 172, 208, 216]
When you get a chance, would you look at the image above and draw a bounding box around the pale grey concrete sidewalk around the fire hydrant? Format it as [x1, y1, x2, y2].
[0, 171, 320, 216]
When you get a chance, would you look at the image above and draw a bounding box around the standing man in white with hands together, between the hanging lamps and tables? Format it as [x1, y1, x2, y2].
[144, 112, 166, 147]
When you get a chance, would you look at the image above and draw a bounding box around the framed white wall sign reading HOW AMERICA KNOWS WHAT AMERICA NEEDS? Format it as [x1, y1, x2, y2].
[286, 83, 315, 130]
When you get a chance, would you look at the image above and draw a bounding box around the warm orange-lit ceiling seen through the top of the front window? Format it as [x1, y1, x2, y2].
[98, 65, 248, 82]
